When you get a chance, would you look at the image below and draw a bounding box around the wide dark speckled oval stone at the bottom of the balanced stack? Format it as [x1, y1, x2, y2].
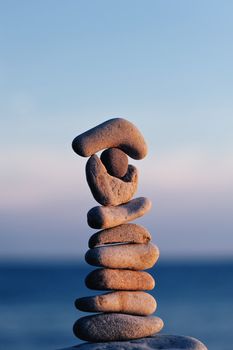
[73, 313, 163, 342]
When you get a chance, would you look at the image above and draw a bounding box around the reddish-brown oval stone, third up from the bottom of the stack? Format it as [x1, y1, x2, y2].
[85, 269, 155, 290]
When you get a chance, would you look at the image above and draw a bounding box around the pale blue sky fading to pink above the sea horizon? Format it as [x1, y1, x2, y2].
[0, 0, 233, 260]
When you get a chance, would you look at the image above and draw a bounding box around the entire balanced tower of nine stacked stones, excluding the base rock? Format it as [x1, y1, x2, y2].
[72, 118, 163, 342]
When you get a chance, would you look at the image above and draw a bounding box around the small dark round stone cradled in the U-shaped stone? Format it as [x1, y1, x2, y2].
[100, 148, 128, 178]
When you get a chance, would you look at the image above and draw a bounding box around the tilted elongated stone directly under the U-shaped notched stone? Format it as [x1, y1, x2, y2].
[87, 197, 151, 229]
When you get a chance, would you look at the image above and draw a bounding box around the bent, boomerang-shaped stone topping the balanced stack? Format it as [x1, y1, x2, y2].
[72, 118, 147, 159]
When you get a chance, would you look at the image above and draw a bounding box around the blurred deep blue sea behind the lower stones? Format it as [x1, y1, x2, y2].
[0, 261, 233, 350]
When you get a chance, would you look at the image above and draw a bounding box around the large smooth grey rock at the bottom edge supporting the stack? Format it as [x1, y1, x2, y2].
[61, 334, 207, 350]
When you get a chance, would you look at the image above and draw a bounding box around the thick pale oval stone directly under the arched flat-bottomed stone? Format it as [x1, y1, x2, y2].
[85, 243, 159, 270]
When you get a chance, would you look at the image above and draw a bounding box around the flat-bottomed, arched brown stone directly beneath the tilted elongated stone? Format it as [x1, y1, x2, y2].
[88, 224, 151, 248]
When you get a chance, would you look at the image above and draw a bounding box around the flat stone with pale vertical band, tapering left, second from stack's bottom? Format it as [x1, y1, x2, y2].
[75, 291, 157, 316]
